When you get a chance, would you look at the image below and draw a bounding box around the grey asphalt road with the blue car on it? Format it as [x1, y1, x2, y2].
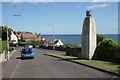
[2, 47, 118, 78]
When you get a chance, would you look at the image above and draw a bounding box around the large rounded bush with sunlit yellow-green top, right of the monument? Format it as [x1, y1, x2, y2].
[96, 39, 120, 62]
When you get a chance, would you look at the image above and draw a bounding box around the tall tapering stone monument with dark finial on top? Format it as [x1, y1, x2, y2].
[81, 11, 97, 59]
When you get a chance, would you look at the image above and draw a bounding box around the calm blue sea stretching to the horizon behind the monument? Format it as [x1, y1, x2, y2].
[41, 34, 118, 46]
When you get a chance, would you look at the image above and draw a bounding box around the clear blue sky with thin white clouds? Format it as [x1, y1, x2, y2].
[2, 0, 118, 34]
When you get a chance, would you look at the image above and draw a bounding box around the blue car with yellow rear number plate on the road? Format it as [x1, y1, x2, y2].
[21, 47, 34, 59]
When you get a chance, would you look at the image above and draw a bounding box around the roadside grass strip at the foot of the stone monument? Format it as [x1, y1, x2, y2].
[45, 53, 120, 73]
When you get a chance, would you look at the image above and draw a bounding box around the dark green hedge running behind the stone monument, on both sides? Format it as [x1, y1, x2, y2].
[66, 39, 120, 63]
